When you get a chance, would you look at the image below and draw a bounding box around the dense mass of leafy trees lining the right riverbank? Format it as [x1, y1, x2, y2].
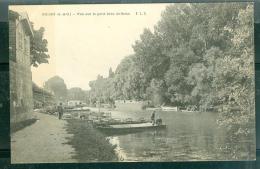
[89, 3, 254, 149]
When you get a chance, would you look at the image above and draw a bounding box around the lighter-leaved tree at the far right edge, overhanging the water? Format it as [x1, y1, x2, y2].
[214, 5, 255, 136]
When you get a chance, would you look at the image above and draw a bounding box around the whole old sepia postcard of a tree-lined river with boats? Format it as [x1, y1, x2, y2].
[8, 2, 256, 164]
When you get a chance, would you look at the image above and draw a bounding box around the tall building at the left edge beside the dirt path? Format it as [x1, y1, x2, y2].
[9, 11, 33, 124]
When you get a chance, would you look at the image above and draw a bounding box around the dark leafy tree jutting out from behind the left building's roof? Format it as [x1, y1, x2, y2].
[30, 27, 50, 67]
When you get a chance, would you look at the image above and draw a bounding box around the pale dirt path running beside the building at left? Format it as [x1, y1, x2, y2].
[11, 113, 77, 163]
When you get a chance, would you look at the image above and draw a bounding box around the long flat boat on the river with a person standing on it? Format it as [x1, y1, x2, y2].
[96, 122, 166, 135]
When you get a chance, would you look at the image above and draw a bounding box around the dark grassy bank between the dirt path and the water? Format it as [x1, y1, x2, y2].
[67, 119, 117, 162]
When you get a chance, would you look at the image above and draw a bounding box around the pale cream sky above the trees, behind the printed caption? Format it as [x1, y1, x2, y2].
[9, 4, 169, 90]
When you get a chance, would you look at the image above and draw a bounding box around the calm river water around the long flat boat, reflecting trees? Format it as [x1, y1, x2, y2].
[103, 111, 255, 161]
